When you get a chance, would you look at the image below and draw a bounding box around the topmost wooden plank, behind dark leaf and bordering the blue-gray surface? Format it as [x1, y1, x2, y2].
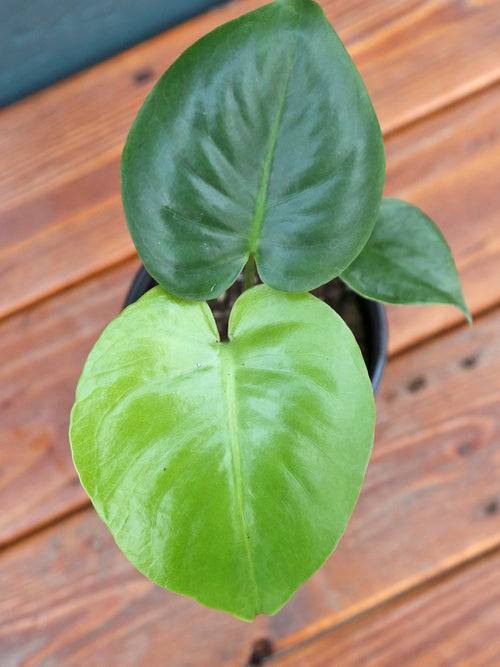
[0, 0, 500, 316]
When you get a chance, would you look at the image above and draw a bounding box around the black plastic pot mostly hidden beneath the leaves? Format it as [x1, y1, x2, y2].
[123, 266, 387, 393]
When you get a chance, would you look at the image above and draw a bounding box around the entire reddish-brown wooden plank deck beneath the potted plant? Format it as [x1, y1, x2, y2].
[0, 0, 500, 667]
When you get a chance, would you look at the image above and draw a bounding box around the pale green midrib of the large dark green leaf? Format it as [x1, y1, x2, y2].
[249, 6, 302, 255]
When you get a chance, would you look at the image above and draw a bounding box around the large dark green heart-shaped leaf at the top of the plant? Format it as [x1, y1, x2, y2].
[122, 0, 385, 299]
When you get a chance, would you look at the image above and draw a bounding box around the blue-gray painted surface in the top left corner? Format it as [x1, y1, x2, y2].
[0, 0, 229, 107]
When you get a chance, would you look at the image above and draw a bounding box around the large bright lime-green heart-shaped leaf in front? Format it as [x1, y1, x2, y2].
[70, 285, 374, 620]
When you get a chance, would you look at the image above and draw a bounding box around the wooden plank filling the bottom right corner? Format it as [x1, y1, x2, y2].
[270, 553, 500, 667]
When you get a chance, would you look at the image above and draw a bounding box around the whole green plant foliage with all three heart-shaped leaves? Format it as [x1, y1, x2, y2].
[70, 0, 470, 620]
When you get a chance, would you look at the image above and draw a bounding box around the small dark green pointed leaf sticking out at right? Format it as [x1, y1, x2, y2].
[341, 199, 471, 322]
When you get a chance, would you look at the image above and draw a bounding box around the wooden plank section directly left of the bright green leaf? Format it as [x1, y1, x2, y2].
[0, 260, 139, 545]
